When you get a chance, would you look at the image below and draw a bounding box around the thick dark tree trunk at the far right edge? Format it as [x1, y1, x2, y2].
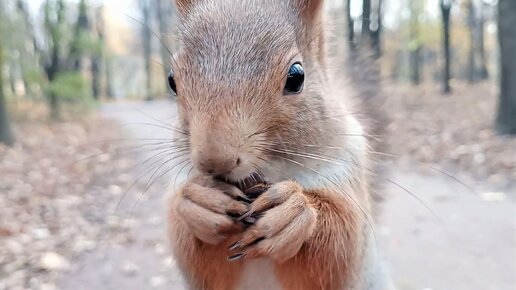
[496, 0, 516, 134]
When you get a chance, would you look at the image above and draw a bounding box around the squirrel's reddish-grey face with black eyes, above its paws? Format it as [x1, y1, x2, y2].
[169, 0, 326, 181]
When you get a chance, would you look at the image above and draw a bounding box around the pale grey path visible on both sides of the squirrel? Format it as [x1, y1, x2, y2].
[60, 101, 516, 290]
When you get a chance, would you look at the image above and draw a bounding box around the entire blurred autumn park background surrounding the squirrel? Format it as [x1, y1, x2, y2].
[0, 0, 516, 290]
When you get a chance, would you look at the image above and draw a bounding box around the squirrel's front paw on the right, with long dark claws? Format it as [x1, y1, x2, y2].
[228, 181, 317, 262]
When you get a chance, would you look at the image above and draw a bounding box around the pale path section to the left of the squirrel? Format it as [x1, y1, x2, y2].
[60, 102, 183, 290]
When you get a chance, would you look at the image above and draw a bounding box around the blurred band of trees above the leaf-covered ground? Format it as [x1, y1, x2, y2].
[0, 0, 516, 135]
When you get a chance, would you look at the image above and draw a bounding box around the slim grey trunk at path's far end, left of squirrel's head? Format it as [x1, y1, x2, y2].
[140, 0, 154, 101]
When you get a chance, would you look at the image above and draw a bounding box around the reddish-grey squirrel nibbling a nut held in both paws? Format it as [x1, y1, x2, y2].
[168, 0, 392, 290]
